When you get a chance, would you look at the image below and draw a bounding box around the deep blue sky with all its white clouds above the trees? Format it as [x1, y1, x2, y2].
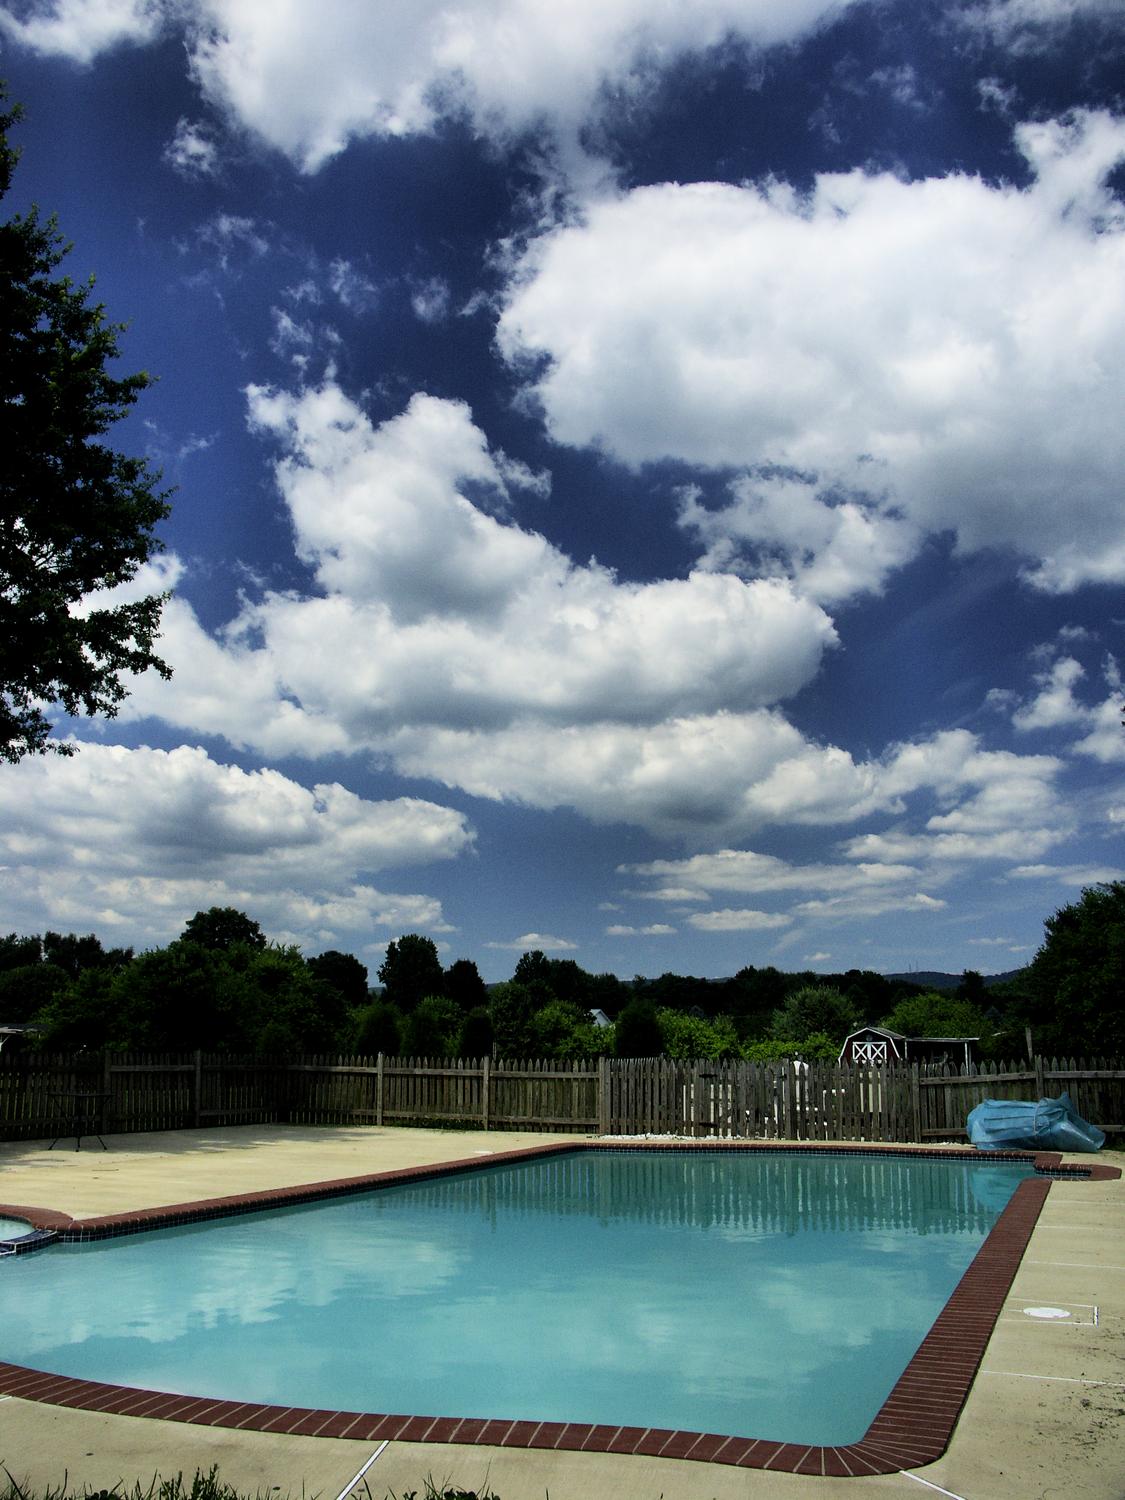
[0, 0, 1125, 980]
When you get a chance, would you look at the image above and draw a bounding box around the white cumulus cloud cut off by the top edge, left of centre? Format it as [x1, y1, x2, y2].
[183, 0, 839, 171]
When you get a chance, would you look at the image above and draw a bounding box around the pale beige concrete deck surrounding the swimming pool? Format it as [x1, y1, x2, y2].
[0, 1127, 1125, 1500]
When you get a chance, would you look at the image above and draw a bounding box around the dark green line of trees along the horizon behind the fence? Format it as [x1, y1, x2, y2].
[0, 882, 1125, 1062]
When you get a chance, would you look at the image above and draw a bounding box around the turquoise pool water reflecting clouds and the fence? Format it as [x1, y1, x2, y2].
[0, 1152, 1031, 1445]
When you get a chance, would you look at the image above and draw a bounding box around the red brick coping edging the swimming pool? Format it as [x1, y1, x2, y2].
[0, 1140, 1121, 1479]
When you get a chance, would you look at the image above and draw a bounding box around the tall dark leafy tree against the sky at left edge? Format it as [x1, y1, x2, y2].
[0, 92, 171, 762]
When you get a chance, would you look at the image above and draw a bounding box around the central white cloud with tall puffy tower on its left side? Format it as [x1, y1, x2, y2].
[125, 383, 846, 828]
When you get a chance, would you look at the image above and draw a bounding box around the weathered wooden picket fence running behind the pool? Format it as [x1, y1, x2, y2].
[0, 1050, 1125, 1142]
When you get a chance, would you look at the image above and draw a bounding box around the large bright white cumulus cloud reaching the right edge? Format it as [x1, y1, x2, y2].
[498, 111, 1125, 599]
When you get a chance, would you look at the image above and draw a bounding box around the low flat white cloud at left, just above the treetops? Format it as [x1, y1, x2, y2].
[0, 744, 474, 947]
